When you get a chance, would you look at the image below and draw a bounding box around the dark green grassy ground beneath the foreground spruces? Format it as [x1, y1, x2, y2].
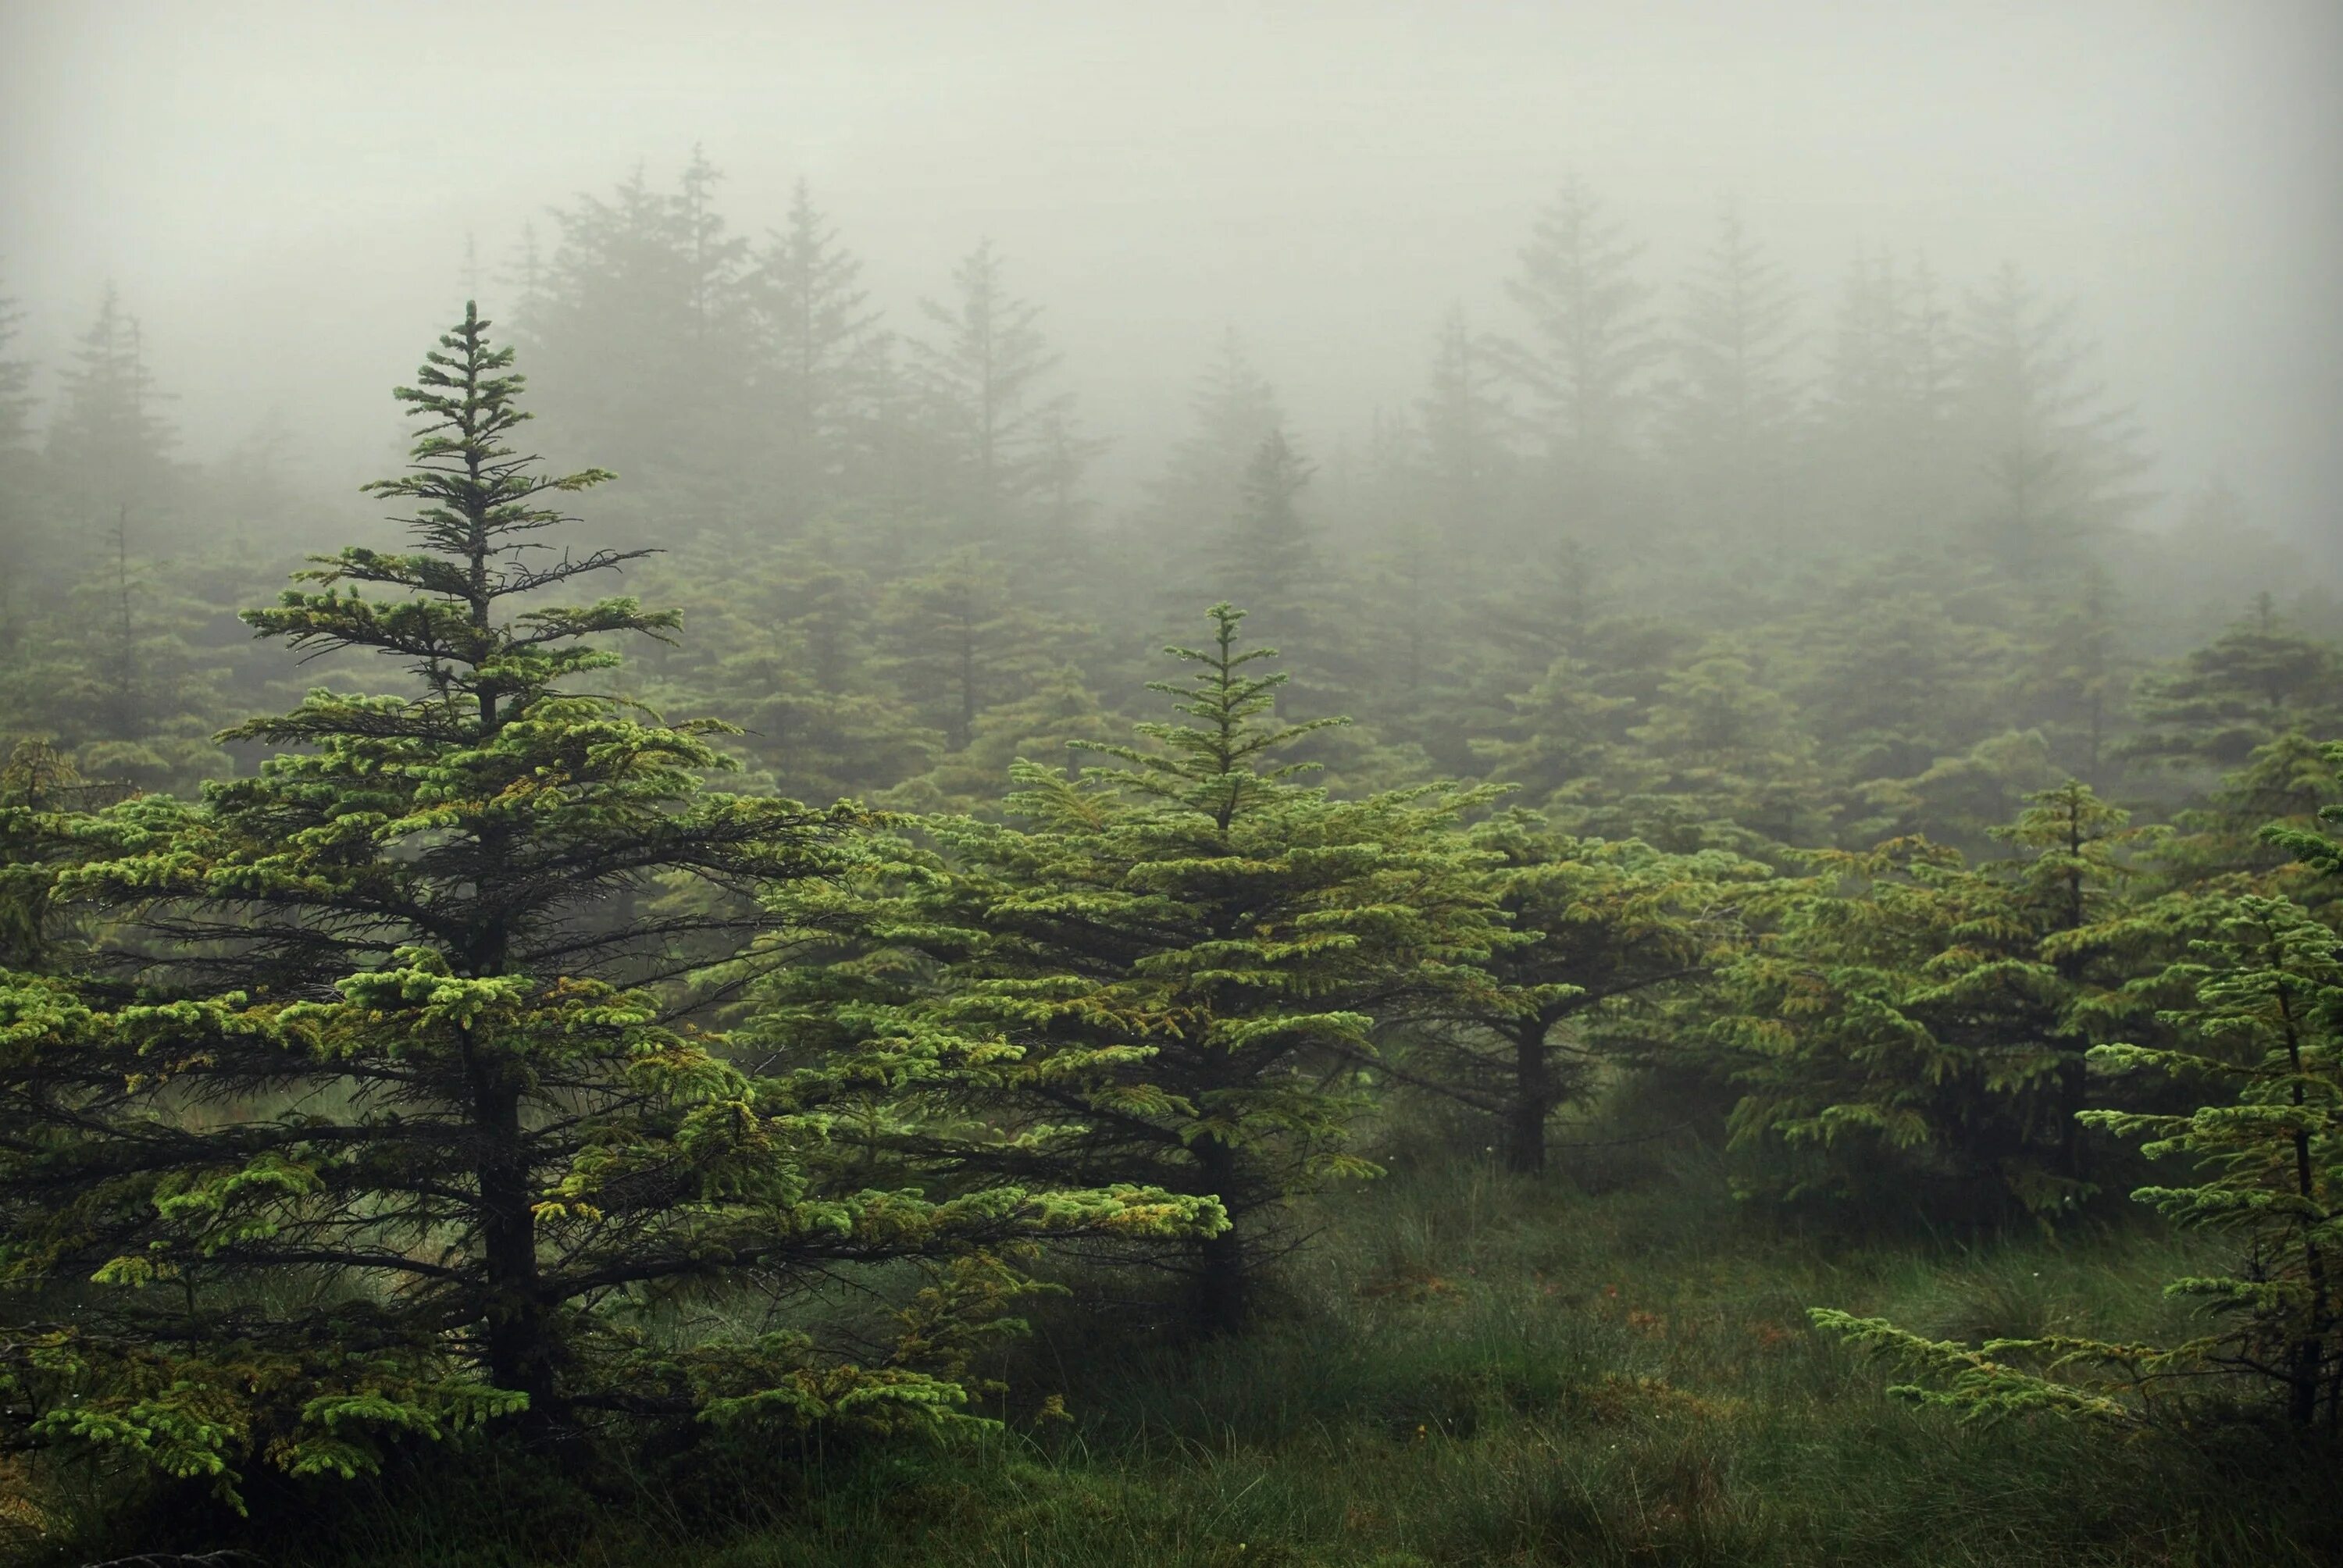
[151, 1129, 2343, 1568]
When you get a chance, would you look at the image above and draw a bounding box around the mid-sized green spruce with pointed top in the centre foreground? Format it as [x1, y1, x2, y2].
[773, 604, 1502, 1334]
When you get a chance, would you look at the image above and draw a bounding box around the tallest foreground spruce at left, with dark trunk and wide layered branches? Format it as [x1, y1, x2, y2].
[0, 309, 1179, 1495]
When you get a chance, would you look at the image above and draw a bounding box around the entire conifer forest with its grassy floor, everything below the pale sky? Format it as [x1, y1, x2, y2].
[0, 5, 2343, 1568]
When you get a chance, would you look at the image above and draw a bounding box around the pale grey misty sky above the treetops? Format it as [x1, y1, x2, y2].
[0, 0, 2343, 539]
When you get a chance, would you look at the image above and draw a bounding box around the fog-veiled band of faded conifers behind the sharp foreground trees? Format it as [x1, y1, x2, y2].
[0, 150, 2343, 849]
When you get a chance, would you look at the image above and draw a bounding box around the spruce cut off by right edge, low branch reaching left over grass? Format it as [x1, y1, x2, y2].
[1813, 747, 2343, 1432]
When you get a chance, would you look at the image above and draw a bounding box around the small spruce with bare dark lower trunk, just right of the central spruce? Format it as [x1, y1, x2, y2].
[1392, 811, 1767, 1172]
